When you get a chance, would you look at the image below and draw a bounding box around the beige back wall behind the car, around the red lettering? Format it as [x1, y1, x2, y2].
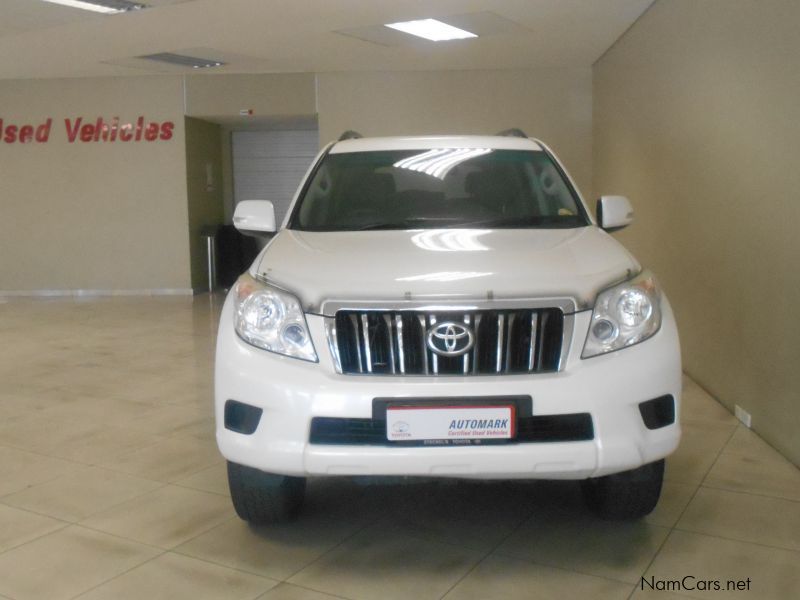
[0, 68, 591, 293]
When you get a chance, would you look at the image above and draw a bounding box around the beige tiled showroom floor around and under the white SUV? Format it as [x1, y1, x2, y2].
[0, 296, 800, 600]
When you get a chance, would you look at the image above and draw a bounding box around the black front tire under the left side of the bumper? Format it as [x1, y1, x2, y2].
[228, 462, 306, 525]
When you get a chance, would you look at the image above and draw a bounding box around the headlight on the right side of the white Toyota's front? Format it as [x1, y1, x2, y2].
[581, 271, 661, 358]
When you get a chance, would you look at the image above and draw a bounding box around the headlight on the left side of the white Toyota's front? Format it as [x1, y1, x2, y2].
[233, 273, 317, 362]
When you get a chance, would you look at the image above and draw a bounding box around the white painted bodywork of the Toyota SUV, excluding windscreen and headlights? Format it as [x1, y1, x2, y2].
[215, 132, 681, 520]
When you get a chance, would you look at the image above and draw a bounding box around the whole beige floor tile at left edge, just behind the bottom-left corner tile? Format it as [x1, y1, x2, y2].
[2, 467, 164, 521]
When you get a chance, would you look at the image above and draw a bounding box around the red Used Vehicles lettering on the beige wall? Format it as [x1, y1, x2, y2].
[0, 116, 175, 144]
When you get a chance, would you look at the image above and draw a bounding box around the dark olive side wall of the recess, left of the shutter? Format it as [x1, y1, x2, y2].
[186, 117, 225, 291]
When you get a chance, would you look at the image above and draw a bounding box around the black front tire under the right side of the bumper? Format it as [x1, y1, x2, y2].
[581, 458, 664, 519]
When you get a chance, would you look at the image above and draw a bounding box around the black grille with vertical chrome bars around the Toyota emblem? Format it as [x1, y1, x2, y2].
[329, 308, 564, 375]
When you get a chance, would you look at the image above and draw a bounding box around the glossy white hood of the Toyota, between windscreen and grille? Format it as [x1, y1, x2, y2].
[251, 227, 640, 313]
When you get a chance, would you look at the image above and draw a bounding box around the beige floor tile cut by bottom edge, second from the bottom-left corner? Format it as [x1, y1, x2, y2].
[78, 553, 278, 600]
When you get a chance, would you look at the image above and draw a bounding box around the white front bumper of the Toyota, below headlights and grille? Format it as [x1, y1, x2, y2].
[215, 295, 681, 479]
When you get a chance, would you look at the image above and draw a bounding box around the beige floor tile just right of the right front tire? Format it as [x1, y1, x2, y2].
[664, 422, 736, 485]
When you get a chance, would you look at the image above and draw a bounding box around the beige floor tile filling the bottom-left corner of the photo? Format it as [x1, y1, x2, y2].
[0, 525, 160, 600]
